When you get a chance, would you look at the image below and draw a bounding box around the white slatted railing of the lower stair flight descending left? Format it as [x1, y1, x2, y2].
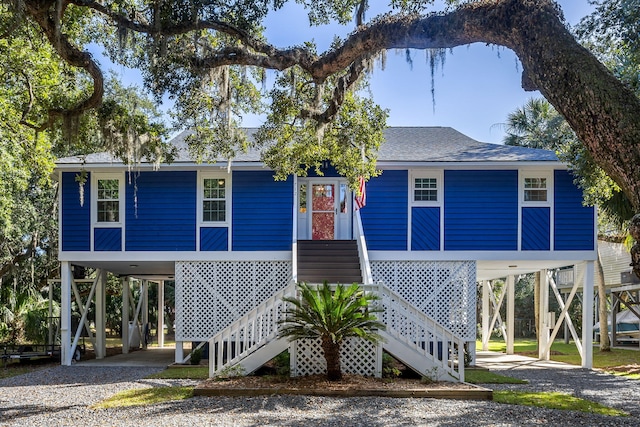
[209, 281, 296, 377]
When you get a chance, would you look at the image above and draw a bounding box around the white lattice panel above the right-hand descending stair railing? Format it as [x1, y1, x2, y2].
[371, 261, 476, 341]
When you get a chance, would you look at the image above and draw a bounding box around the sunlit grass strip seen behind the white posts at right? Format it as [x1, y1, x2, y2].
[476, 339, 640, 377]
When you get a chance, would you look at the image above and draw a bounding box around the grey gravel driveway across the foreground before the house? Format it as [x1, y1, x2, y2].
[0, 366, 640, 427]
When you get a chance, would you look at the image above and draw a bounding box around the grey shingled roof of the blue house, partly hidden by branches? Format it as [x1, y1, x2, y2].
[56, 126, 558, 166]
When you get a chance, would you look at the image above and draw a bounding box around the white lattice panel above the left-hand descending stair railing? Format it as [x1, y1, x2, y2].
[175, 261, 292, 341]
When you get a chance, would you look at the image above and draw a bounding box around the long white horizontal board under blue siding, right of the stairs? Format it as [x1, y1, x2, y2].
[369, 251, 598, 262]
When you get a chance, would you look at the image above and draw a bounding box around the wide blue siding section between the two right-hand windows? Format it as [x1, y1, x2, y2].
[444, 170, 518, 251]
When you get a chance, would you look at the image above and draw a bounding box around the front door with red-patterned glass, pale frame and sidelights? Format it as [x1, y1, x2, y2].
[298, 178, 351, 240]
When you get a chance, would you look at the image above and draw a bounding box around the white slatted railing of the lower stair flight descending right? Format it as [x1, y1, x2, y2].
[370, 282, 464, 381]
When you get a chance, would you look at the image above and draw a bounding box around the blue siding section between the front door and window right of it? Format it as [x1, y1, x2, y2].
[360, 170, 408, 251]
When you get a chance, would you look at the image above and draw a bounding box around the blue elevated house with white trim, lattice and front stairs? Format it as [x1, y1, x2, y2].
[57, 127, 596, 380]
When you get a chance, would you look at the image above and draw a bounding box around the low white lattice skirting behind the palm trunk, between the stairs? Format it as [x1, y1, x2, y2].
[290, 338, 382, 377]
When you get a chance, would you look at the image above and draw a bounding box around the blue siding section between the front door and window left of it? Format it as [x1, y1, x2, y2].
[232, 171, 293, 251]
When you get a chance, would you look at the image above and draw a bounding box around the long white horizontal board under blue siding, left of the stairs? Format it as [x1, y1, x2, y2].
[58, 251, 292, 263]
